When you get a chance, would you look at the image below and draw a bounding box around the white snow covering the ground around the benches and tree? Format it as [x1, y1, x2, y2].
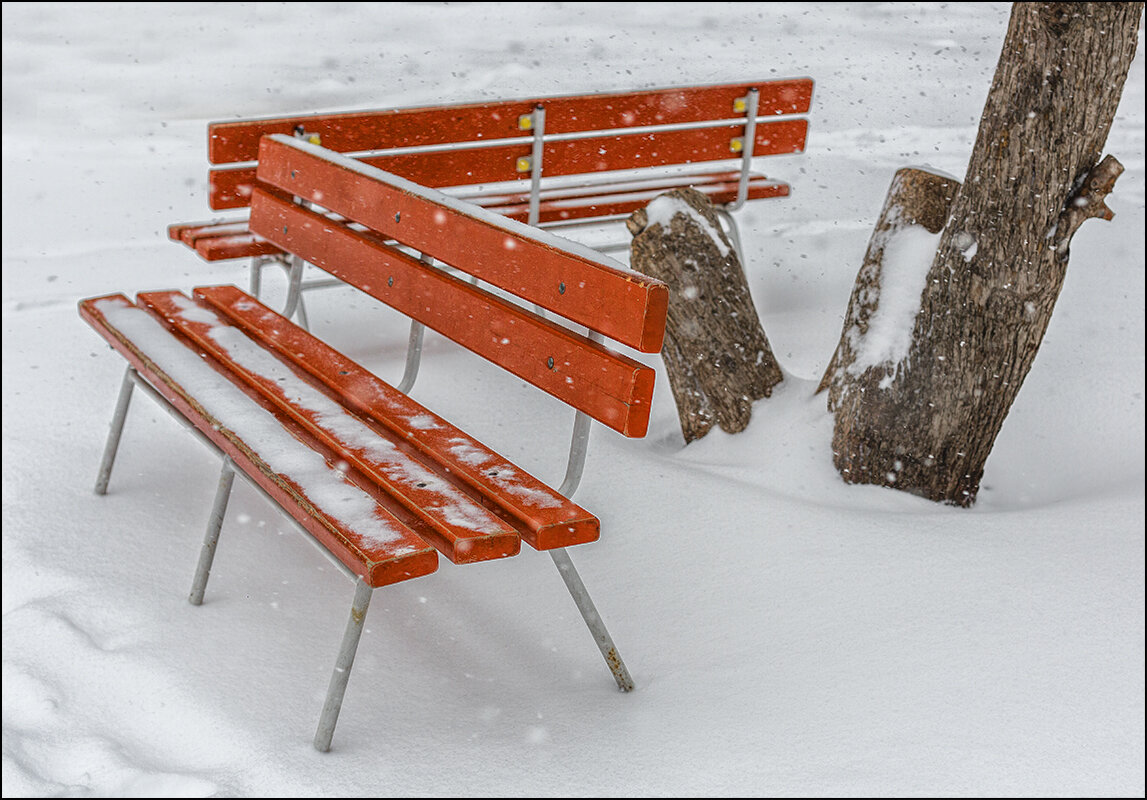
[2, 3, 1145, 797]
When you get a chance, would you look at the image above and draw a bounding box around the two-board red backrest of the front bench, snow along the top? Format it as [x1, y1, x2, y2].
[250, 134, 669, 436]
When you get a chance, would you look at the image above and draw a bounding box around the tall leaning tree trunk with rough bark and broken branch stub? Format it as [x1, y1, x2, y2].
[829, 2, 1144, 506]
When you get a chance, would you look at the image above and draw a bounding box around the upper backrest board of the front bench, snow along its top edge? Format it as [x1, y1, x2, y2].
[250, 137, 669, 352]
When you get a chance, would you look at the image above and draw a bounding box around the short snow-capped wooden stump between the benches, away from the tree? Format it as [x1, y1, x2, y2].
[626, 188, 783, 443]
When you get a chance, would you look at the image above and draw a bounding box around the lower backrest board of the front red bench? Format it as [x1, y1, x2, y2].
[250, 189, 655, 436]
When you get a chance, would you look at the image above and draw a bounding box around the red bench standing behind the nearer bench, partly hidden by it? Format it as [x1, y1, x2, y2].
[169, 78, 813, 324]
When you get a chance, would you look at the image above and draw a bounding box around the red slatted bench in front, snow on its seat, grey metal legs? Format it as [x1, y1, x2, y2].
[79, 135, 668, 751]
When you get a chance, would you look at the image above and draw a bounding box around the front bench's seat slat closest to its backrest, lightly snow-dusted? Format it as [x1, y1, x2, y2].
[195, 286, 600, 550]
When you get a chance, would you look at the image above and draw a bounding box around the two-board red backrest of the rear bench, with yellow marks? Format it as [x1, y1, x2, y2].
[208, 78, 812, 210]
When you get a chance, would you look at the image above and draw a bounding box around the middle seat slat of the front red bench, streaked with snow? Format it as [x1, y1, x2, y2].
[136, 286, 521, 564]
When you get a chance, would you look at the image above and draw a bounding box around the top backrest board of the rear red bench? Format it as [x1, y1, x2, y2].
[208, 78, 813, 164]
